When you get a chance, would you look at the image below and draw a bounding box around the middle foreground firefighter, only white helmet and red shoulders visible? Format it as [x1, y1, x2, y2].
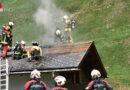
[51, 76, 68, 90]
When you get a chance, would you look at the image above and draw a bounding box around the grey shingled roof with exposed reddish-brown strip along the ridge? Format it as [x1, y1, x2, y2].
[0, 41, 106, 74]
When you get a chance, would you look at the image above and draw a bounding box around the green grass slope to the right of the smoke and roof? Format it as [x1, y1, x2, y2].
[56, 0, 130, 90]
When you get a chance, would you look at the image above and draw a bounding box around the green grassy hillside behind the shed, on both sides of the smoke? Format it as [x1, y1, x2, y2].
[0, 0, 130, 90]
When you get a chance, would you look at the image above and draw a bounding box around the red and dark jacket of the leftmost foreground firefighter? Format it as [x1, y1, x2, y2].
[24, 79, 48, 90]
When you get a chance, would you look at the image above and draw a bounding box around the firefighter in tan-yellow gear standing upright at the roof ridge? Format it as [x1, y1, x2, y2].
[64, 15, 73, 43]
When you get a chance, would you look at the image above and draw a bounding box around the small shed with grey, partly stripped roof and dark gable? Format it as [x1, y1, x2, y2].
[4, 41, 107, 90]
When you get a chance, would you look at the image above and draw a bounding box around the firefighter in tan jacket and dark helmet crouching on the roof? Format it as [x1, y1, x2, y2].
[27, 41, 42, 61]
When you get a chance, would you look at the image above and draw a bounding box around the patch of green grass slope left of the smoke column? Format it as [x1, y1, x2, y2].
[0, 0, 40, 44]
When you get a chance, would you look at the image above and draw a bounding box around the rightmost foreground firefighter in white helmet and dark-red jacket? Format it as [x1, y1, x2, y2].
[85, 69, 113, 90]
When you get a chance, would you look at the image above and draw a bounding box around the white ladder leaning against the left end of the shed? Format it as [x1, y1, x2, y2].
[0, 59, 9, 90]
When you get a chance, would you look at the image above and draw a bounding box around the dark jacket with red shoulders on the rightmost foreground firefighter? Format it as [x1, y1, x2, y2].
[85, 78, 113, 90]
